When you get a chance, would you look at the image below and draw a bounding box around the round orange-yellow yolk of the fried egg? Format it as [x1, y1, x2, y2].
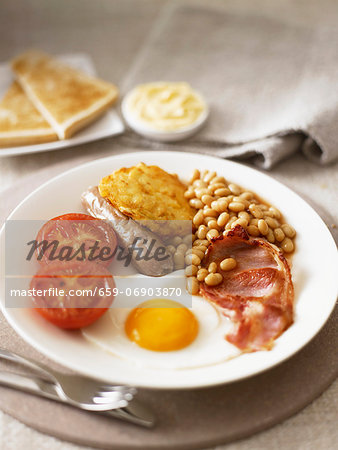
[125, 299, 198, 352]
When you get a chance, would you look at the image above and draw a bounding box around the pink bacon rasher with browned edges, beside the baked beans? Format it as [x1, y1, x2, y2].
[201, 225, 294, 352]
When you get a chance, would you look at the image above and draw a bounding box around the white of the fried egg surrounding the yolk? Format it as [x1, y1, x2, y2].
[82, 273, 241, 370]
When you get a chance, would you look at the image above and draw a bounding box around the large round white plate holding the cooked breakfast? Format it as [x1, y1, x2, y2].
[1, 152, 338, 388]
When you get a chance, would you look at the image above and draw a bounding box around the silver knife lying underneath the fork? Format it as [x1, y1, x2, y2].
[0, 371, 155, 428]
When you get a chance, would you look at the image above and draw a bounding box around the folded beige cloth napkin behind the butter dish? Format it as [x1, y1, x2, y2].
[122, 4, 338, 168]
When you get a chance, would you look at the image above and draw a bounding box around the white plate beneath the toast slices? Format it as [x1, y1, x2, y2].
[0, 54, 125, 157]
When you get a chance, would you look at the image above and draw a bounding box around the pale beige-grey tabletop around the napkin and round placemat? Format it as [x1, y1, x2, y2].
[0, 0, 338, 450]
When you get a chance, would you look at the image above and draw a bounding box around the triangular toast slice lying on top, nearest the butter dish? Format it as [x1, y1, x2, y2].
[12, 50, 118, 139]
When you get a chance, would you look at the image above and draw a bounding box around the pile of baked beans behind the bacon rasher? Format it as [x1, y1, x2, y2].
[186, 169, 296, 264]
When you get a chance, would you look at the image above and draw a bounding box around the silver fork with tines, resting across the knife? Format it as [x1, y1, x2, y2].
[0, 349, 136, 411]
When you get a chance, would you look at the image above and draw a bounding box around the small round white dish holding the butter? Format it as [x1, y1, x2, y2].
[121, 91, 209, 142]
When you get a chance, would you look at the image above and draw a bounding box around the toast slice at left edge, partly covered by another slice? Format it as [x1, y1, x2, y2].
[0, 82, 58, 147]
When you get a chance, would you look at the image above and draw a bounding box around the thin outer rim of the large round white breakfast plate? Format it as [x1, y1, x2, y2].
[0, 151, 338, 389]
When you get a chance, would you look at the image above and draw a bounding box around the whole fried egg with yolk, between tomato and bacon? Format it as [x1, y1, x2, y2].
[82, 277, 240, 370]
